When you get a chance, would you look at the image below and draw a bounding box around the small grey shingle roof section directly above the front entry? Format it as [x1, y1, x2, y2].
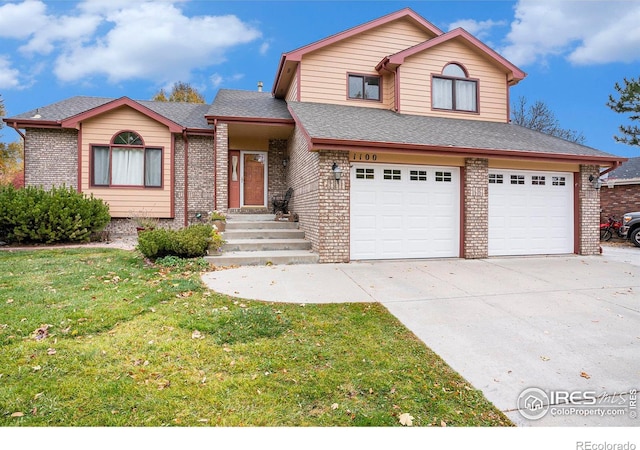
[208, 89, 292, 120]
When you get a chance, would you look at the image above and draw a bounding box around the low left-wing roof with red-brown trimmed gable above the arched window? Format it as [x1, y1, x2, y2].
[4, 96, 211, 132]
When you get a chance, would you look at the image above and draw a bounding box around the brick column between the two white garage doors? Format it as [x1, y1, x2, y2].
[463, 158, 489, 259]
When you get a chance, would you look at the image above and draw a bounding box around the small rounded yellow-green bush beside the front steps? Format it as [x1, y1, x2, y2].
[138, 224, 213, 260]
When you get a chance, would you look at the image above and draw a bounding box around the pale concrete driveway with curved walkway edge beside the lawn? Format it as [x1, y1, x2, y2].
[203, 247, 640, 426]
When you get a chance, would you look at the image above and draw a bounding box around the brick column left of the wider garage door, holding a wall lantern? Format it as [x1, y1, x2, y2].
[318, 151, 351, 263]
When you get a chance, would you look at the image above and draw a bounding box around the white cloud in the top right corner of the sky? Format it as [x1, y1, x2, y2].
[501, 0, 640, 65]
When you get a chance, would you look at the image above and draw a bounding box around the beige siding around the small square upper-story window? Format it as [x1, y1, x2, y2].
[298, 20, 430, 109]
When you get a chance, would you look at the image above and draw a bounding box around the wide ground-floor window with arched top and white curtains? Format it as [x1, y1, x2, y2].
[91, 131, 162, 187]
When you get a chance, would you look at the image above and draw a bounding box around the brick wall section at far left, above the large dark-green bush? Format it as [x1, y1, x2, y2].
[24, 128, 79, 189]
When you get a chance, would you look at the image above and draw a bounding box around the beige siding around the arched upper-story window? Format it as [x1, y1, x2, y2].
[400, 40, 508, 122]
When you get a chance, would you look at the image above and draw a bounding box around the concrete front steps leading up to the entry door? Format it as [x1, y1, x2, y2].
[205, 214, 319, 267]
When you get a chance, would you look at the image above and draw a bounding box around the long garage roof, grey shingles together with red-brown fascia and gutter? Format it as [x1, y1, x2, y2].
[289, 102, 626, 165]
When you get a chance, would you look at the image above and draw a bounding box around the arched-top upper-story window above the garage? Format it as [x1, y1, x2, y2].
[431, 63, 478, 112]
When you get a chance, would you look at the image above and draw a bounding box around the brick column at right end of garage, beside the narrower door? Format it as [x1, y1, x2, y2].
[574, 165, 600, 255]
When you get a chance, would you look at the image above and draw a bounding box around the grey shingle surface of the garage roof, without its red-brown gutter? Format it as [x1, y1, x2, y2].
[289, 102, 611, 157]
